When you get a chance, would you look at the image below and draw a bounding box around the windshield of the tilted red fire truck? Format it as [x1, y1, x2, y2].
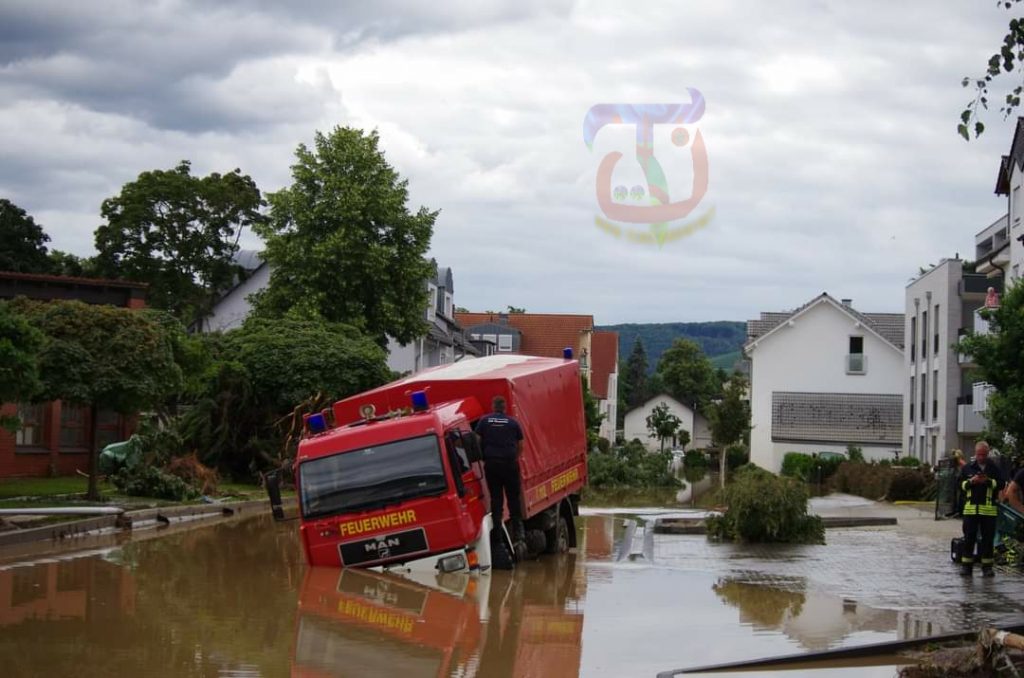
[299, 435, 447, 518]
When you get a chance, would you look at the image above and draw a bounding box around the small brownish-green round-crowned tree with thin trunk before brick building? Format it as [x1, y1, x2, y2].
[11, 299, 181, 500]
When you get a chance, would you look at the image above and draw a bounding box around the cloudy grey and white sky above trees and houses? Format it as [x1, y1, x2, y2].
[0, 0, 1012, 324]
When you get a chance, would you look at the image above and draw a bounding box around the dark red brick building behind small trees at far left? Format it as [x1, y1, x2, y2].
[0, 271, 146, 477]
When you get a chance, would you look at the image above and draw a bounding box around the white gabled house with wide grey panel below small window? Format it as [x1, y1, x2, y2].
[743, 293, 906, 472]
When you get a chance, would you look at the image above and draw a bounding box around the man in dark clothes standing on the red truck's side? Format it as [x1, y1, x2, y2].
[474, 395, 525, 542]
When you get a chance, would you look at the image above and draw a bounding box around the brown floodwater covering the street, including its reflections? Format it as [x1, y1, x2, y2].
[0, 514, 1024, 678]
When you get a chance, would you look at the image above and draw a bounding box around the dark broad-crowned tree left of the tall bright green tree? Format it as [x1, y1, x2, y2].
[95, 160, 263, 324]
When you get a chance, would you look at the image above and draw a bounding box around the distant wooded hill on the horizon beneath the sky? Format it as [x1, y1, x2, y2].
[597, 321, 746, 371]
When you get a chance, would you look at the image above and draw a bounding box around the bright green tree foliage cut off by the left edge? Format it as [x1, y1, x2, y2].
[0, 301, 43, 430]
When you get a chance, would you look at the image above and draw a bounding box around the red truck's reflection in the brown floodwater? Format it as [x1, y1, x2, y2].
[292, 555, 583, 678]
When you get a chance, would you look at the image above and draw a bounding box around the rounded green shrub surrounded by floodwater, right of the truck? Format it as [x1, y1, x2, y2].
[707, 464, 824, 544]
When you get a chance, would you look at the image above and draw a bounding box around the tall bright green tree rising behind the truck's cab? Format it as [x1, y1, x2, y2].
[256, 127, 437, 346]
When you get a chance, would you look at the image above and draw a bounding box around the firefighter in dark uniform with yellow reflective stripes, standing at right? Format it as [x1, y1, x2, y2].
[961, 440, 1004, 577]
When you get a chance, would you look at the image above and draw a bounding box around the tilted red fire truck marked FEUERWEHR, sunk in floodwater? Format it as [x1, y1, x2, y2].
[295, 356, 587, 573]
